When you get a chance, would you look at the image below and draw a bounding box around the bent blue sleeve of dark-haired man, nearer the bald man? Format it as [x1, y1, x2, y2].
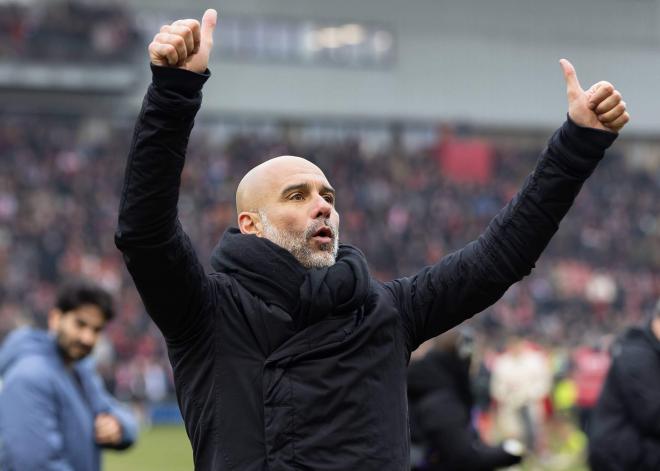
[84, 361, 138, 450]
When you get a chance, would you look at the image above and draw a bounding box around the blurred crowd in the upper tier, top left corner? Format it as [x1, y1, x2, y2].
[0, 0, 139, 64]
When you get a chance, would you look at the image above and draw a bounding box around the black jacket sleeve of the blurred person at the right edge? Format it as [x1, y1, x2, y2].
[611, 345, 660, 440]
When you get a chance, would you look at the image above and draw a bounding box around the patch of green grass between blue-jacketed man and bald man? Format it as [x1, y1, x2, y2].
[103, 426, 193, 471]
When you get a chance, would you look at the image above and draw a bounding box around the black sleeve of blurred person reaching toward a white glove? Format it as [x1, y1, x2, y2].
[419, 391, 520, 471]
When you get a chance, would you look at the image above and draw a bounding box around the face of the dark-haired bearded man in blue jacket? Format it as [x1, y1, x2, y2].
[48, 304, 106, 363]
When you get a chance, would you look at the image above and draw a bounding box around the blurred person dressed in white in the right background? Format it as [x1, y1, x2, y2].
[490, 338, 552, 451]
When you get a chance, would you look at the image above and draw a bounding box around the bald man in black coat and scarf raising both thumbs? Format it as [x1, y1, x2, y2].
[116, 10, 628, 471]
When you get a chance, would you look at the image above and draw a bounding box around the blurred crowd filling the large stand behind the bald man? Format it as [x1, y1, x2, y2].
[0, 111, 660, 446]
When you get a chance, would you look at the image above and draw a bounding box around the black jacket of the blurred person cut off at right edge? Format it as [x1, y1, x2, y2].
[589, 324, 660, 471]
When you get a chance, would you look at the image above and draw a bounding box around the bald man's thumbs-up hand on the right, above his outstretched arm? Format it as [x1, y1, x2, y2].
[559, 59, 630, 132]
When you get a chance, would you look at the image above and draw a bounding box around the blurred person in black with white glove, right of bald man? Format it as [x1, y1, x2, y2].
[408, 327, 524, 471]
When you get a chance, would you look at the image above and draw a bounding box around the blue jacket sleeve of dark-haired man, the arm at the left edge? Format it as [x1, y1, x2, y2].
[0, 368, 74, 471]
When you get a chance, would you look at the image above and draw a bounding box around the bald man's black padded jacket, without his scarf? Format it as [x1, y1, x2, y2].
[115, 67, 614, 471]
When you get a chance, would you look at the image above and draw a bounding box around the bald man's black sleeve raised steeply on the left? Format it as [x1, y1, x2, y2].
[115, 66, 212, 340]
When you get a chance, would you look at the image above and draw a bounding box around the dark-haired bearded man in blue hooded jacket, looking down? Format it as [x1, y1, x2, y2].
[0, 281, 137, 471]
